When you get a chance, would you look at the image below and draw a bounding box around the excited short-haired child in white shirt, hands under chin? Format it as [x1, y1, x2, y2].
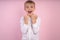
[20, 1, 41, 40]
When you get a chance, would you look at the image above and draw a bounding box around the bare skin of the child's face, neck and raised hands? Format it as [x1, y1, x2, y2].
[24, 3, 37, 24]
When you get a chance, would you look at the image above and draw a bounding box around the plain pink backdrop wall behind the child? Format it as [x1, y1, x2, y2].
[0, 0, 60, 40]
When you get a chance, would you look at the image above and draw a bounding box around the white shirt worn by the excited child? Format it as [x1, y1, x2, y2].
[20, 16, 41, 39]
